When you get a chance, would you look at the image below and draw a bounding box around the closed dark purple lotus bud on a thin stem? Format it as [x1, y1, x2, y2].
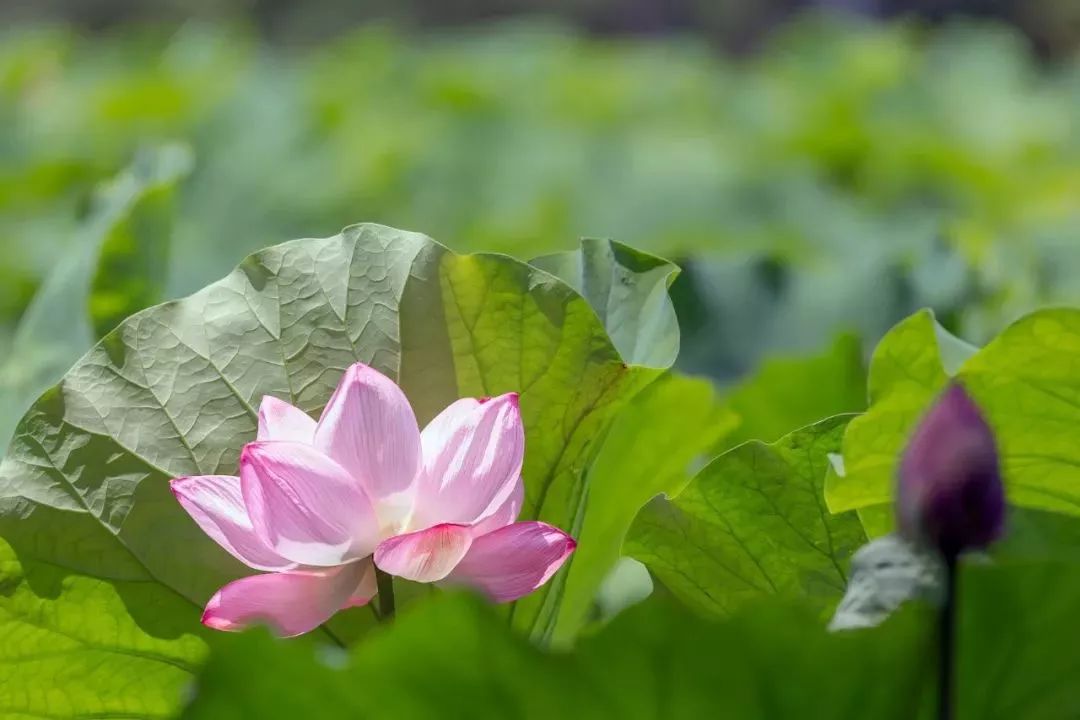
[896, 382, 1005, 556]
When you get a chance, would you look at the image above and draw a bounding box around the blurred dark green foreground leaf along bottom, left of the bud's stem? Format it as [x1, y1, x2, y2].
[185, 597, 919, 720]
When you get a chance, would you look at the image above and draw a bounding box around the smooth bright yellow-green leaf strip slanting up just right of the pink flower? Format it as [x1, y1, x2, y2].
[540, 375, 735, 643]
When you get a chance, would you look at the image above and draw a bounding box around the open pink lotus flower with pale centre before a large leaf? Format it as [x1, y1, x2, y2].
[172, 363, 576, 636]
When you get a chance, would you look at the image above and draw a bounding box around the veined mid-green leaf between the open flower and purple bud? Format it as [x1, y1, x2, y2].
[625, 416, 866, 614]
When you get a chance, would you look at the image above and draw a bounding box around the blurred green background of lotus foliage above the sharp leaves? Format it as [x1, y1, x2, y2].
[0, 0, 1080, 445]
